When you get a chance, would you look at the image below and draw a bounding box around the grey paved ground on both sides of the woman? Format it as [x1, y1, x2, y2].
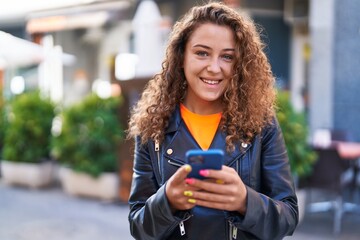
[0, 181, 360, 240]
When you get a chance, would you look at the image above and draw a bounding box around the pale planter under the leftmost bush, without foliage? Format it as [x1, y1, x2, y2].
[1, 160, 54, 188]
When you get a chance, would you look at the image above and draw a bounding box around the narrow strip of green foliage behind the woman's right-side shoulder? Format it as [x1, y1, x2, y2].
[277, 91, 316, 178]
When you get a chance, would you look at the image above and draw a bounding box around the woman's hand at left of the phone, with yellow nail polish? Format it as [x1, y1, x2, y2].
[165, 164, 197, 212]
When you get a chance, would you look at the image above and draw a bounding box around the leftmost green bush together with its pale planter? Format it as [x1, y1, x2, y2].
[1, 91, 54, 188]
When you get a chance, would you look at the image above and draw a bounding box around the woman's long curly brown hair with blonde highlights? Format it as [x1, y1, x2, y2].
[128, 2, 276, 151]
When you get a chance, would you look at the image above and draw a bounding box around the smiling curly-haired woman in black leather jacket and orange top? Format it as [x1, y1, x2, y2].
[129, 3, 298, 239]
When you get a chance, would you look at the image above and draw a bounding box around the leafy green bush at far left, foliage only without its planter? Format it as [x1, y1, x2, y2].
[2, 91, 54, 163]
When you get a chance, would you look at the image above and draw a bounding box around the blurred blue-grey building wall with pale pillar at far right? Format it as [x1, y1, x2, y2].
[309, 0, 360, 142]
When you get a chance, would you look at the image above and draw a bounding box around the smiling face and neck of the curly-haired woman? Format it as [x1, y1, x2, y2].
[183, 23, 235, 114]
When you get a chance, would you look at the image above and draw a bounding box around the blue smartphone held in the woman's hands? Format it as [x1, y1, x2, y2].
[186, 149, 224, 179]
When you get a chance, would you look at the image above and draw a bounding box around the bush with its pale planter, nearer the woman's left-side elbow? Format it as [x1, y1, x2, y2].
[52, 94, 123, 200]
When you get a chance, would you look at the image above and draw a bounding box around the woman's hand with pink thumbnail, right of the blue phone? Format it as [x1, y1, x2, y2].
[186, 166, 247, 214]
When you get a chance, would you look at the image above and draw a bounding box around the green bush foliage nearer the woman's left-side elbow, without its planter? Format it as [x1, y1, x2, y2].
[52, 94, 123, 177]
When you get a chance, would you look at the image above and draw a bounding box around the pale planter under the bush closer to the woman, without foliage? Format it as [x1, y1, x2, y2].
[59, 167, 119, 201]
